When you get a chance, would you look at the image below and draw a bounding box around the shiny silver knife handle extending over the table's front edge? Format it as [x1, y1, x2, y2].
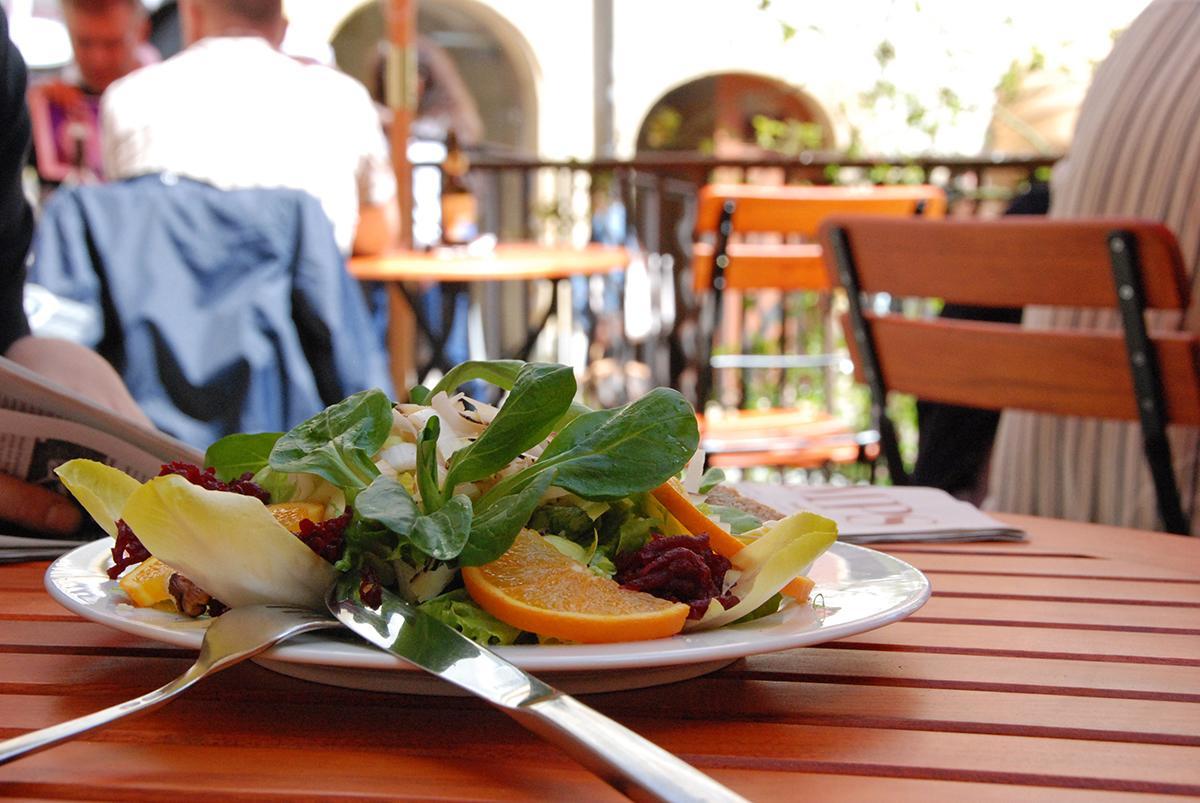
[502, 693, 746, 803]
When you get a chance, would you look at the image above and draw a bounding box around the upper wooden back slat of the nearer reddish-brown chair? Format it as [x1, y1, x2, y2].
[822, 216, 1189, 310]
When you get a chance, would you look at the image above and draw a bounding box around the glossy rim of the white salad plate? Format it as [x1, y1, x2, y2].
[44, 539, 930, 672]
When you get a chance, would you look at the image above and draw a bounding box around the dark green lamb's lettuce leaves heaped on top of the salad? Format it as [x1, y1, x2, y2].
[205, 360, 700, 592]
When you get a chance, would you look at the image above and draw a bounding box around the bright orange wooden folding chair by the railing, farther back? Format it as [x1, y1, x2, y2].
[692, 185, 946, 468]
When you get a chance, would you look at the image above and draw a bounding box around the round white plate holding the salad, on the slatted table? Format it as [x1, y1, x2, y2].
[46, 539, 929, 694]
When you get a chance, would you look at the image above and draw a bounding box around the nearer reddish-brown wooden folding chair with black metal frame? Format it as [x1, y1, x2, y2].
[822, 217, 1200, 533]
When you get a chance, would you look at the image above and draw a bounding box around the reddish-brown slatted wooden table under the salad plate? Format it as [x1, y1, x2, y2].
[0, 516, 1200, 803]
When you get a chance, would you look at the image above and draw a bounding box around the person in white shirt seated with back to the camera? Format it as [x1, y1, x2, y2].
[101, 0, 398, 254]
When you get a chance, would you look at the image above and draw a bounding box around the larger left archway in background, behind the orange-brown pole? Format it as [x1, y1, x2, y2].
[331, 0, 538, 152]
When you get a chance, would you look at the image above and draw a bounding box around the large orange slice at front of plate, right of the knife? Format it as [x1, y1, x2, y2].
[462, 529, 688, 643]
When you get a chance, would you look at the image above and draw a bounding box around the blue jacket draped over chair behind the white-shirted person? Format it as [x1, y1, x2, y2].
[31, 175, 390, 448]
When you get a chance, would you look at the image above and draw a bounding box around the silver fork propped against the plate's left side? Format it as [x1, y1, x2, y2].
[0, 605, 341, 765]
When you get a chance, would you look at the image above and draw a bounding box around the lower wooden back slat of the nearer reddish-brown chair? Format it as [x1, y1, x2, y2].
[844, 316, 1200, 425]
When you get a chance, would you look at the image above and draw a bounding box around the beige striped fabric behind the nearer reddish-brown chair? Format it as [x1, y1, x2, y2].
[984, 0, 1200, 534]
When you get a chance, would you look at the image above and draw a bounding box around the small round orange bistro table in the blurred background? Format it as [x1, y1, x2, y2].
[349, 242, 629, 388]
